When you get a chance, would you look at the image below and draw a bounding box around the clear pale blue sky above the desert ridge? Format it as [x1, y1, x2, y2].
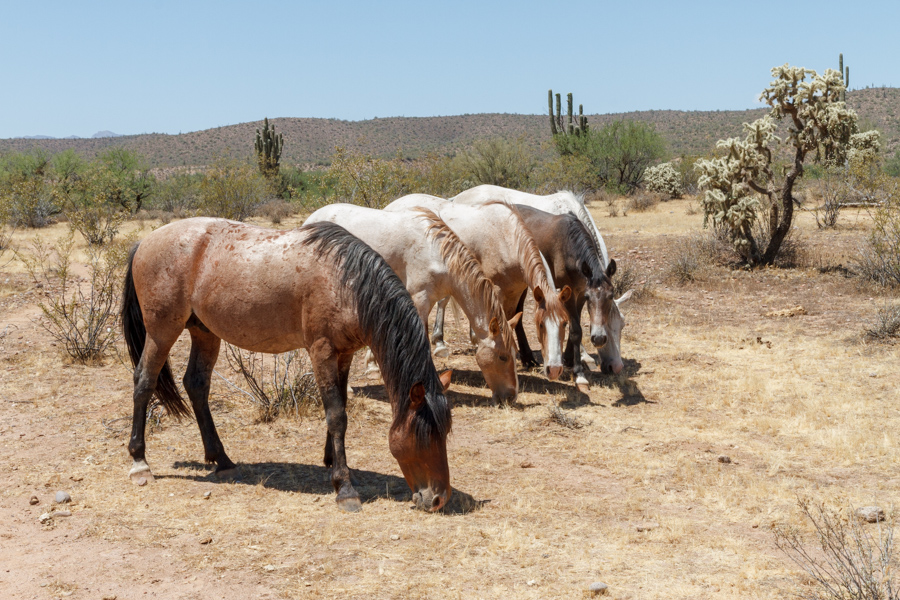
[0, 0, 900, 138]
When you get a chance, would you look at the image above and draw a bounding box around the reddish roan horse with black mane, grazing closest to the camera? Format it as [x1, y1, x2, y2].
[122, 218, 451, 511]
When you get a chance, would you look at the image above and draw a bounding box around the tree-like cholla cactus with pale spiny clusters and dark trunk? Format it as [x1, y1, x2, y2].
[694, 64, 857, 264]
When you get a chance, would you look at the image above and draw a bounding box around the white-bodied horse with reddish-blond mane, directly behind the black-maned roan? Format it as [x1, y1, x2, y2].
[306, 204, 522, 401]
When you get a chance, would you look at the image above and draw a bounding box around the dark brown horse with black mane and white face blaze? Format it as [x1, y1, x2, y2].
[515, 204, 616, 386]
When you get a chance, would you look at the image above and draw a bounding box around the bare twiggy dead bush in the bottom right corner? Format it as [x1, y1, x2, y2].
[775, 500, 900, 600]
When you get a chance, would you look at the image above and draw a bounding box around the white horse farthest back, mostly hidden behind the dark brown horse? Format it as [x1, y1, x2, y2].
[451, 185, 632, 373]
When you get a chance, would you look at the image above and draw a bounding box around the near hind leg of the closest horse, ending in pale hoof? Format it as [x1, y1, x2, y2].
[128, 335, 178, 485]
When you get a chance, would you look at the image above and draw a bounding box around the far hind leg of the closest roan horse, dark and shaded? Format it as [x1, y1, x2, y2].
[182, 327, 238, 479]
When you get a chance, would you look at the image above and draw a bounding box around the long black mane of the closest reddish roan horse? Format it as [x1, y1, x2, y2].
[301, 222, 451, 446]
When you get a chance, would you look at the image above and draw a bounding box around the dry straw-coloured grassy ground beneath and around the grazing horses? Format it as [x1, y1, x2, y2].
[0, 200, 900, 599]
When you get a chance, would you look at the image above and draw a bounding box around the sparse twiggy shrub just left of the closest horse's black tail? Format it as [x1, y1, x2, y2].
[16, 231, 127, 364]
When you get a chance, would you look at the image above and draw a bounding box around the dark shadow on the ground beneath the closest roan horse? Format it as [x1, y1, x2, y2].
[162, 461, 490, 515]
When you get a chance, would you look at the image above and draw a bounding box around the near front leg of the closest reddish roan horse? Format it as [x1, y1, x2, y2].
[309, 342, 362, 512]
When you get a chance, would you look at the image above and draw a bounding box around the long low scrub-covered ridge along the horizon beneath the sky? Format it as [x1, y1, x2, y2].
[0, 88, 900, 167]
